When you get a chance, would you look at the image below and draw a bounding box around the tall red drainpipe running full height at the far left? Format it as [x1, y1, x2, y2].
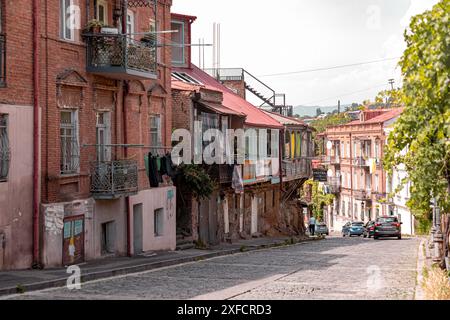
[32, 0, 40, 268]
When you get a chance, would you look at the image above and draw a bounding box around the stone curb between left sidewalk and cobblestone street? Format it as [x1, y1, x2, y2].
[0, 239, 322, 296]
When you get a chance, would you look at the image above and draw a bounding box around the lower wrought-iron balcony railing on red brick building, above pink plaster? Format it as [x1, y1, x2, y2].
[91, 160, 138, 199]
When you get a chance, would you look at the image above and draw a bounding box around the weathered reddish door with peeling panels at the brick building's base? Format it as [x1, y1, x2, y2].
[63, 215, 84, 266]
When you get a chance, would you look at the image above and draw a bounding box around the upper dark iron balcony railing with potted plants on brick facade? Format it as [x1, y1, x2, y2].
[84, 33, 157, 80]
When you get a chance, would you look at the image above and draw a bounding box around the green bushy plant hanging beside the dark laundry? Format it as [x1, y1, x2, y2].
[178, 164, 215, 200]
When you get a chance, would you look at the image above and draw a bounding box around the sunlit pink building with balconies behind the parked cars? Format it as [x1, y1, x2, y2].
[321, 108, 402, 231]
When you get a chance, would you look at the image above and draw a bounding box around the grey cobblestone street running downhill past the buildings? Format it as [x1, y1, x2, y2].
[4, 237, 420, 300]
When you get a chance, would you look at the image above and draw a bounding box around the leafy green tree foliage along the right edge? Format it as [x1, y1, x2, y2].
[384, 0, 450, 219]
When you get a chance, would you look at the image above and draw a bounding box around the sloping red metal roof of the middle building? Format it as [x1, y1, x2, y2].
[173, 65, 283, 129]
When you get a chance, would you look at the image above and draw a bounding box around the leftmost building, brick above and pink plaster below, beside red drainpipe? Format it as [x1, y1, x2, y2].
[0, 0, 34, 270]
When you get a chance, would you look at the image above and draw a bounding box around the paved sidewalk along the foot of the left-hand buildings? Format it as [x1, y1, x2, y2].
[0, 237, 318, 295]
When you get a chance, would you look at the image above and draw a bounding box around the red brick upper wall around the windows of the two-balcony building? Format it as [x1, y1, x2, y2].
[40, 0, 172, 203]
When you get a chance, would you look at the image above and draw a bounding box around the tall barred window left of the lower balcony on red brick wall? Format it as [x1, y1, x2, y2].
[60, 111, 80, 174]
